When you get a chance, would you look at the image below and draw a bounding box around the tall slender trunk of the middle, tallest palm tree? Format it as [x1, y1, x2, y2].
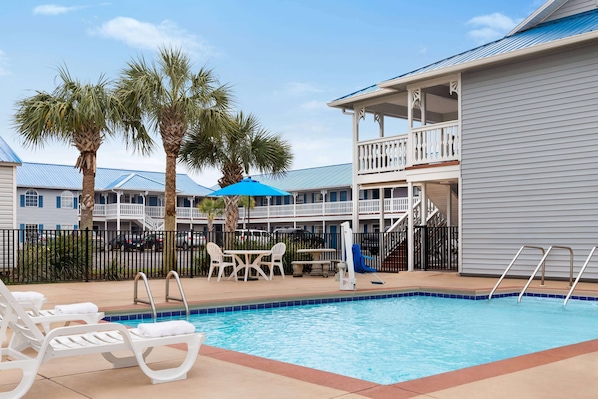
[162, 152, 177, 275]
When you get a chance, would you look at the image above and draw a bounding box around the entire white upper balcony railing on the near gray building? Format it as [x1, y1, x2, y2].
[357, 121, 461, 175]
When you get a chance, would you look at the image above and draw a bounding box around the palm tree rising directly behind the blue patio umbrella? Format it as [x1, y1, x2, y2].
[180, 112, 293, 233]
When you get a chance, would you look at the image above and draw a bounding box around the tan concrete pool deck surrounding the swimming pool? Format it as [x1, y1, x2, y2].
[0, 272, 598, 399]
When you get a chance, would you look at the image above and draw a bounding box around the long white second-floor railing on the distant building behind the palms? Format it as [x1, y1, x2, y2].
[93, 198, 417, 220]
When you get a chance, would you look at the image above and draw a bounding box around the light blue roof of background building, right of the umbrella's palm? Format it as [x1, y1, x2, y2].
[215, 163, 353, 192]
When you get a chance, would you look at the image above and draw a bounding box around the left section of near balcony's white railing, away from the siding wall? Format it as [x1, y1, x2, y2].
[357, 134, 408, 174]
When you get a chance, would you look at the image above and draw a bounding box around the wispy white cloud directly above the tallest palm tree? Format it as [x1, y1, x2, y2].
[89, 17, 216, 56]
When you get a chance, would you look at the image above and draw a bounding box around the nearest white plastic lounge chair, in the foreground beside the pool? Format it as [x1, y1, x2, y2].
[0, 284, 205, 399]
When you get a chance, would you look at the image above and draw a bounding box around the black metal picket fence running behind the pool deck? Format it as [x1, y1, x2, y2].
[0, 227, 457, 284]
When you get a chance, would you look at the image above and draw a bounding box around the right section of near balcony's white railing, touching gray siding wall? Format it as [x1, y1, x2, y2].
[411, 121, 461, 165]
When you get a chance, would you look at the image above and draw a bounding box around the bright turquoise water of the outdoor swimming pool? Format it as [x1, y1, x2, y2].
[122, 296, 598, 384]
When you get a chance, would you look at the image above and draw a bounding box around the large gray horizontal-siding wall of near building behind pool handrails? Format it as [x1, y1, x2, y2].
[462, 46, 598, 278]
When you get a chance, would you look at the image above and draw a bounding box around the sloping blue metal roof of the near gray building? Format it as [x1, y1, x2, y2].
[334, 9, 598, 101]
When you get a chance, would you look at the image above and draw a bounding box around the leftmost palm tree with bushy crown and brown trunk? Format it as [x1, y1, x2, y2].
[14, 67, 152, 230]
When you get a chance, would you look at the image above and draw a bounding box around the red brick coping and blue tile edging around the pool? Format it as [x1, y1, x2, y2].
[105, 287, 598, 399]
